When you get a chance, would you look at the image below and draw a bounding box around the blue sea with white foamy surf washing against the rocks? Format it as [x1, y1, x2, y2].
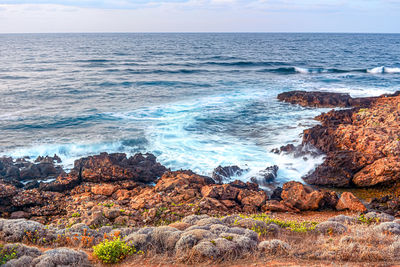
[0, 33, 400, 184]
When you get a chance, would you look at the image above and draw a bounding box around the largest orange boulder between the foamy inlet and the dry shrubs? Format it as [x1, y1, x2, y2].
[281, 181, 324, 210]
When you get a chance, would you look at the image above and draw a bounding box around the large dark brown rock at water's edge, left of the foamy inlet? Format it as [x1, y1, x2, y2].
[74, 153, 167, 183]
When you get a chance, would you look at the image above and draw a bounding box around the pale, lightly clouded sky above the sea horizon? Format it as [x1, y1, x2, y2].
[0, 0, 400, 33]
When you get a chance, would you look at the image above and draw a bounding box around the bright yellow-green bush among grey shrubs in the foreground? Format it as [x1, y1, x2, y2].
[93, 237, 136, 263]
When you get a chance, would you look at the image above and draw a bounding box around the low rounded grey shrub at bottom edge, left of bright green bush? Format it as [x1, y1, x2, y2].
[32, 248, 92, 267]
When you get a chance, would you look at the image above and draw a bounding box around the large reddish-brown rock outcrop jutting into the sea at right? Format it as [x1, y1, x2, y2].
[278, 91, 400, 187]
